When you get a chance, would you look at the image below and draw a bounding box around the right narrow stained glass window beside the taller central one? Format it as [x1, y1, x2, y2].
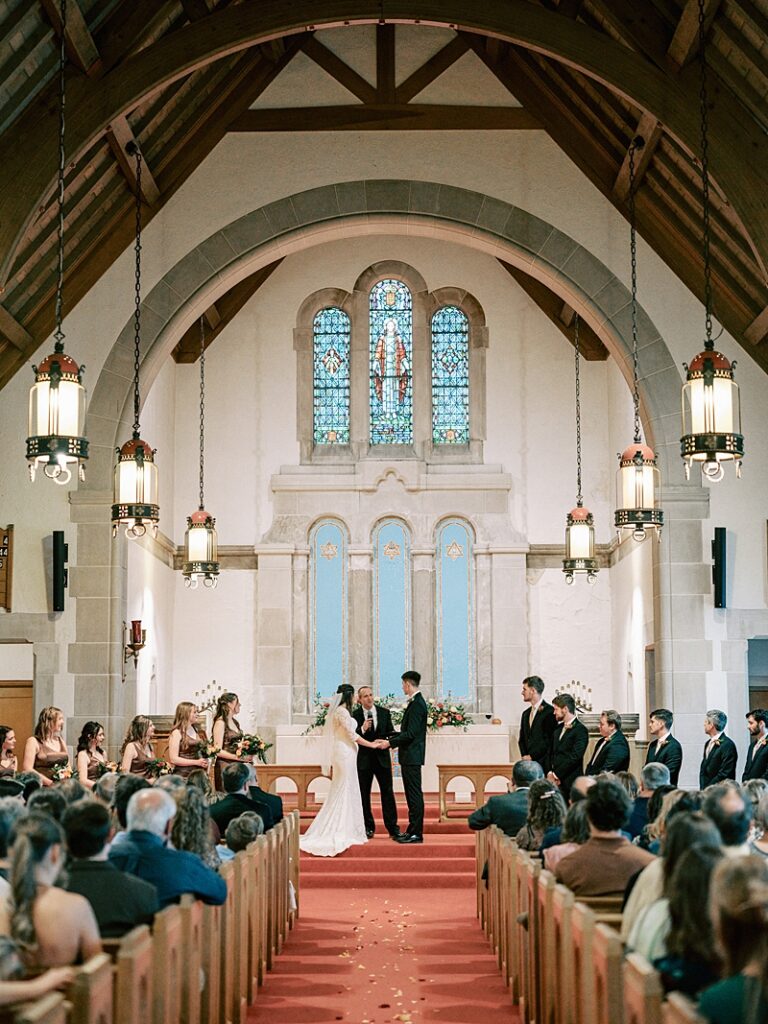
[432, 306, 469, 444]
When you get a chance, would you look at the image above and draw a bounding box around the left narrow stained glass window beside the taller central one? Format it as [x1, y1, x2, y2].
[312, 307, 349, 444]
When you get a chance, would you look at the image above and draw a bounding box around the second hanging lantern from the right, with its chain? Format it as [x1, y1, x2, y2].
[613, 136, 664, 541]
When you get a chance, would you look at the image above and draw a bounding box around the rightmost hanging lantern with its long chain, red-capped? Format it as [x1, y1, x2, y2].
[680, 0, 744, 482]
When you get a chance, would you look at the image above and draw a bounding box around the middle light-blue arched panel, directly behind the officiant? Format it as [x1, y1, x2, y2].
[373, 519, 412, 694]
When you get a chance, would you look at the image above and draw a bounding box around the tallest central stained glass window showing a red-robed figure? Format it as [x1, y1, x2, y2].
[369, 280, 414, 444]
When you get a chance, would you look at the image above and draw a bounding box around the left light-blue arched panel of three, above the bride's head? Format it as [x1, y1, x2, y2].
[308, 519, 349, 697]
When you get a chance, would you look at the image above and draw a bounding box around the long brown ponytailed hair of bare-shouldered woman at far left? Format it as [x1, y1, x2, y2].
[10, 811, 65, 957]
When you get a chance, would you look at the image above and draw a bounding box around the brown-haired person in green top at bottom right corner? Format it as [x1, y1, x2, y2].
[698, 857, 768, 1024]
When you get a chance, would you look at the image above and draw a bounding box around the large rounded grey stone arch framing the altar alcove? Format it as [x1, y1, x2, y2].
[87, 179, 683, 490]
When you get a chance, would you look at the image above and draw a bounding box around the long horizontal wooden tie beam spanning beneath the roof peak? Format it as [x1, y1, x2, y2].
[229, 103, 542, 132]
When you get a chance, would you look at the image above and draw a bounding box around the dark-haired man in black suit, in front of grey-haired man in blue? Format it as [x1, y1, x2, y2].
[62, 800, 160, 939]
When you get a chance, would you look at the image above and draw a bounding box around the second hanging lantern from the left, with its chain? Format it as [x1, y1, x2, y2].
[112, 149, 160, 540]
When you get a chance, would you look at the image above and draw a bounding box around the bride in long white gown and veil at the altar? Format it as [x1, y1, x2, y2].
[299, 683, 380, 857]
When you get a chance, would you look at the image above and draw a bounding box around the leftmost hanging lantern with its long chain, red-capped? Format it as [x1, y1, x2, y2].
[27, 0, 88, 484]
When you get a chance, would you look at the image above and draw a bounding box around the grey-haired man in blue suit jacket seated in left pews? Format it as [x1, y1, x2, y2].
[110, 787, 226, 908]
